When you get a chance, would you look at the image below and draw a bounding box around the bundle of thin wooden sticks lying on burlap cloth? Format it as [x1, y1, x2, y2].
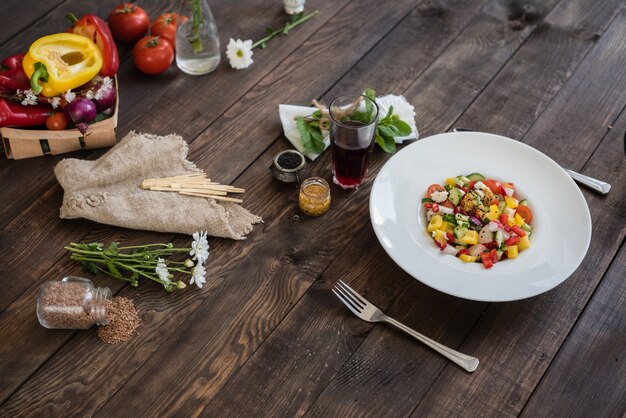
[141, 173, 245, 203]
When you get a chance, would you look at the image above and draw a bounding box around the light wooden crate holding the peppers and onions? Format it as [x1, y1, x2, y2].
[0, 78, 120, 160]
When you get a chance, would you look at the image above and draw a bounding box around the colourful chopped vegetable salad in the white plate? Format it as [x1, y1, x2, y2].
[422, 173, 533, 268]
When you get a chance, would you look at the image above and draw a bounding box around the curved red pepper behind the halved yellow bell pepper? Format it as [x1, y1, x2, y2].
[67, 13, 120, 77]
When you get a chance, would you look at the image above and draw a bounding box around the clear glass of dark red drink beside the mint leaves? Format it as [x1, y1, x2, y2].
[329, 94, 378, 189]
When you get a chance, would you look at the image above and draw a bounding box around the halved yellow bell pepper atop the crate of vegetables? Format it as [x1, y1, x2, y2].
[22, 33, 103, 97]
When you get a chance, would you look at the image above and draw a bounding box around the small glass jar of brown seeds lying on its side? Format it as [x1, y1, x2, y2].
[37, 276, 111, 329]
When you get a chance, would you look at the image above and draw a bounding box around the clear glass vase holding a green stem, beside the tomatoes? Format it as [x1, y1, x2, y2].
[176, 0, 220, 75]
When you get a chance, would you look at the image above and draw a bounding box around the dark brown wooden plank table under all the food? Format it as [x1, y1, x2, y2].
[0, 0, 626, 417]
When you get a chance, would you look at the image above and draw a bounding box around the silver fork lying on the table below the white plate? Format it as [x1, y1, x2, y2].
[332, 280, 478, 372]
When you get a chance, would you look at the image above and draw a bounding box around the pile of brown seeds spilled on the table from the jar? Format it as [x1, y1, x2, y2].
[98, 296, 139, 344]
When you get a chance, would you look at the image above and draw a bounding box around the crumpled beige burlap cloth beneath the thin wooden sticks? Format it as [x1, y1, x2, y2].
[54, 132, 262, 240]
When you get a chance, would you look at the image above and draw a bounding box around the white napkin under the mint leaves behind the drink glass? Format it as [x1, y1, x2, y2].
[278, 94, 419, 160]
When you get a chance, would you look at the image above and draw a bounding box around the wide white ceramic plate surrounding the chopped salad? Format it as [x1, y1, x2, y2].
[370, 132, 591, 302]
